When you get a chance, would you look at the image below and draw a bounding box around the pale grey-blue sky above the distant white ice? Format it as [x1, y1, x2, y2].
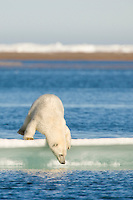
[0, 0, 133, 44]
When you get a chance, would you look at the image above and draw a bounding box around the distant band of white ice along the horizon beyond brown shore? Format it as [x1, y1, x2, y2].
[0, 42, 133, 53]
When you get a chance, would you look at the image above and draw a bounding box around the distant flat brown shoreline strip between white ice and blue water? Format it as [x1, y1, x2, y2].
[0, 52, 133, 62]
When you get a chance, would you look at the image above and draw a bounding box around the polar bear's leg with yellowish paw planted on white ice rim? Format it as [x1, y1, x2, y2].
[24, 120, 36, 140]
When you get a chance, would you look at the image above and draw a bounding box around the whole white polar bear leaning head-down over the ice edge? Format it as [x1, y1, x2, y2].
[18, 94, 71, 164]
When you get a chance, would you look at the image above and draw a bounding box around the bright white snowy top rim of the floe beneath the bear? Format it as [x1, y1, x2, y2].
[0, 138, 133, 148]
